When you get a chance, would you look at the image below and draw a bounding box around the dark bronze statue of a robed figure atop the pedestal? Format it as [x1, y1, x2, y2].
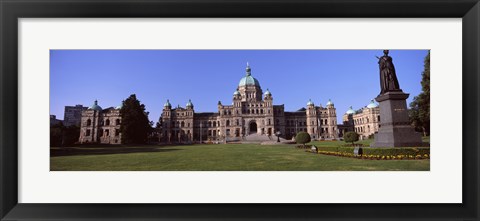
[377, 50, 401, 94]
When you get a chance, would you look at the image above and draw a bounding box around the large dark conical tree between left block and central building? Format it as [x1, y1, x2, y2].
[120, 94, 152, 144]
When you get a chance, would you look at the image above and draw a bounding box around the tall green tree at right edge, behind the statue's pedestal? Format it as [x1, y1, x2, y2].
[409, 51, 430, 136]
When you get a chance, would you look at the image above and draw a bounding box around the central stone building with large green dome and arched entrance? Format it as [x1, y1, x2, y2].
[159, 64, 338, 142]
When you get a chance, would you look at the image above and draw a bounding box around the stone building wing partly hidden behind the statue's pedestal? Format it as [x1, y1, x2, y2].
[340, 100, 380, 140]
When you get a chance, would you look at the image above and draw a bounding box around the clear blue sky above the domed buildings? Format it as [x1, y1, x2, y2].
[50, 50, 428, 122]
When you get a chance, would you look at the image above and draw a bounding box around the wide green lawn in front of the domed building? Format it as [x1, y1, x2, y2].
[50, 141, 430, 171]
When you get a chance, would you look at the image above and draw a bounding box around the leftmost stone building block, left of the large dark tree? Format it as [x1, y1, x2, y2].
[79, 101, 122, 144]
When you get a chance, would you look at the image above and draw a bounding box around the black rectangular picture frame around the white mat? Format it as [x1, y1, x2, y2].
[0, 0, 480, 220]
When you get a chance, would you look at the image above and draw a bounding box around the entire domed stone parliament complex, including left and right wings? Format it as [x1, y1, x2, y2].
[79, 64, 380, 144]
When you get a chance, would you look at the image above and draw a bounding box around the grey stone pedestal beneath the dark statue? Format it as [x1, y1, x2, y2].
[370, 90, 423, 147]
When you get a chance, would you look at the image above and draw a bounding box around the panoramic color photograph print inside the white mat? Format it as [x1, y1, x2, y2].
[50, 49, 431, 171]
